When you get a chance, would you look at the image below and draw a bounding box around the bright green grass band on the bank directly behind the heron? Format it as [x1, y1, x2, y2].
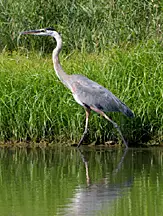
[0, 41, 163, 144]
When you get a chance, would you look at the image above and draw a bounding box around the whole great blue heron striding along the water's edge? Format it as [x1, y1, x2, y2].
[21, 28, 134, 148]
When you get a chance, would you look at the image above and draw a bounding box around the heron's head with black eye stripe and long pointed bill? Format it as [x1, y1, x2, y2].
[20, 27, 59, 38]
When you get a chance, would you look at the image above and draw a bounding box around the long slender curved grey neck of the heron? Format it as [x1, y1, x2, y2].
[52, 35, 68, 87]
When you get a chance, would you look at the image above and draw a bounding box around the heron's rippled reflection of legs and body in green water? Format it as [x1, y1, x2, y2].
[60, 149, 132, 216]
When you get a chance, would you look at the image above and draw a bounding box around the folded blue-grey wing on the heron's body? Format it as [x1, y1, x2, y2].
[72, 75, 124, 112]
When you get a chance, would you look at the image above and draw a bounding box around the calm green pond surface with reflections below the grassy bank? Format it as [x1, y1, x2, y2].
[0, 147, 163, 216]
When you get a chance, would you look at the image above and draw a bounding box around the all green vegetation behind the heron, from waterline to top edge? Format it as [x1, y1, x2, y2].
[0, 0, 163, 143]
